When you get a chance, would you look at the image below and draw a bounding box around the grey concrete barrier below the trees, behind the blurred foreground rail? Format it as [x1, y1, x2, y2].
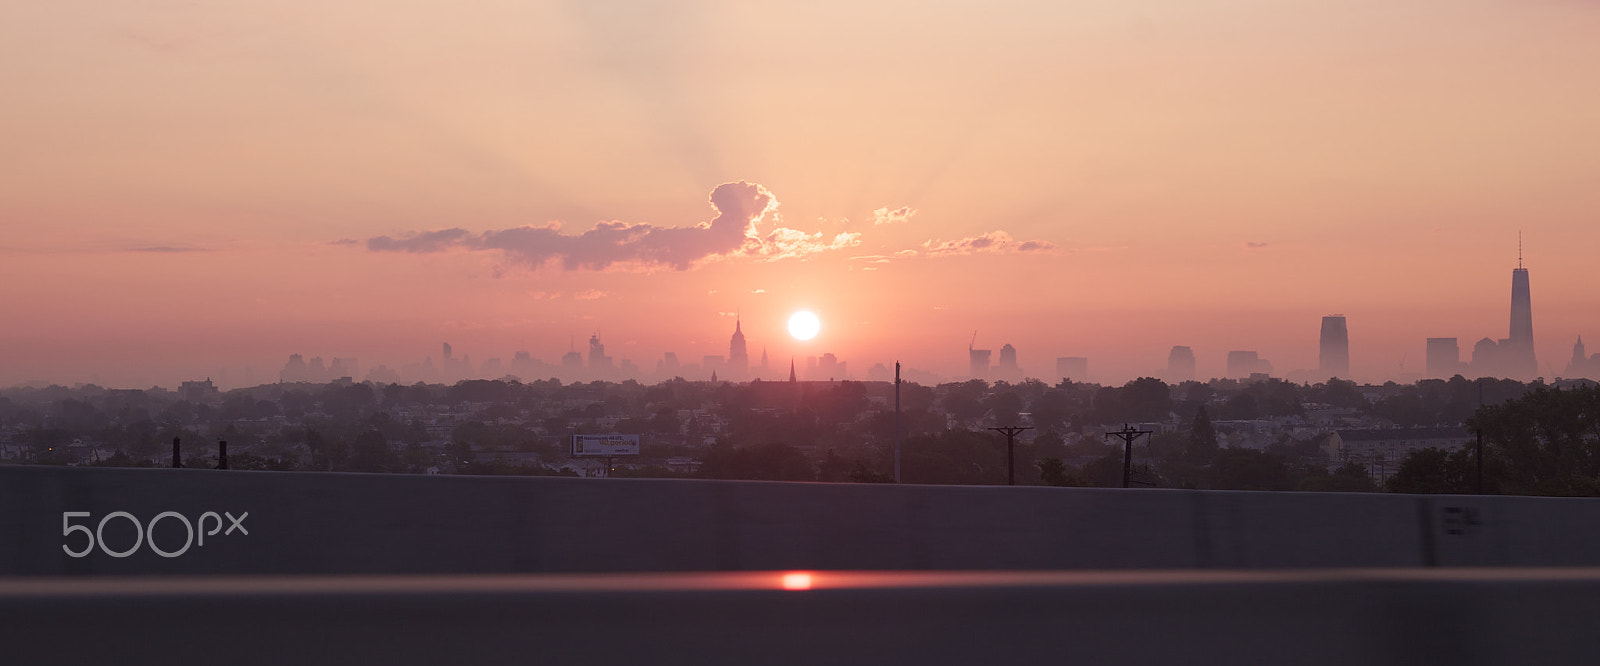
[0, 466, 1600, 575]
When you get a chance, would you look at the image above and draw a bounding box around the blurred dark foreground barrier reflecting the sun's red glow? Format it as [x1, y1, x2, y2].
[0, 568, 1600, 666]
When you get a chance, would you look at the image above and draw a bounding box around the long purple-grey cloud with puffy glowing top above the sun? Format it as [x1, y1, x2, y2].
[366, 181, 861, 271]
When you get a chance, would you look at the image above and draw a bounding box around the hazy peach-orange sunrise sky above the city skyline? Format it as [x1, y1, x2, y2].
[0, 0, 1600, 386]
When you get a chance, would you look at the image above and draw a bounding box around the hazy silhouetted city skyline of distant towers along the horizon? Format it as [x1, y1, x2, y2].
[5, 246, 1600, 387]
